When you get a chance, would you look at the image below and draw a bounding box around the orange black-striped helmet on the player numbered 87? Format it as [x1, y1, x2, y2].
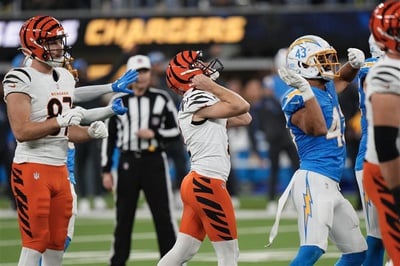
[19, 16, 72, 67]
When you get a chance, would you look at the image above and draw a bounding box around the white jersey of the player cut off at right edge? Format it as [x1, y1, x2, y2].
[365, 56, 400, 164]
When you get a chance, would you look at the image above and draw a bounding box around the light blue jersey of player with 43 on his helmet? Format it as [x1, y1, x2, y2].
[282, 81, 346, 182]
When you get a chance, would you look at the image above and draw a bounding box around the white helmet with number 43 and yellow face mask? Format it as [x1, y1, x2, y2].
[286, 35, 340, 80]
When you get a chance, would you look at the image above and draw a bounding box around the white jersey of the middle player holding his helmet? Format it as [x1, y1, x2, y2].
[178, 90, 231, 181]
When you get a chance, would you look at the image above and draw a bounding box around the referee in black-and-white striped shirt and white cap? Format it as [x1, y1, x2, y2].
[102, 55, 180, 266]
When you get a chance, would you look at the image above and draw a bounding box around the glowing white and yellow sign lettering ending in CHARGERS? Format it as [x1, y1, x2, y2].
[0, 16, 247, 48]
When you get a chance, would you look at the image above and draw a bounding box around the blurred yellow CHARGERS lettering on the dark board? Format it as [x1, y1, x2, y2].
[84, 16, 247, 49]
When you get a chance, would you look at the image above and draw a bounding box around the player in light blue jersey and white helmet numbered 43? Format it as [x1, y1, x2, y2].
[270, 35, 367, 266]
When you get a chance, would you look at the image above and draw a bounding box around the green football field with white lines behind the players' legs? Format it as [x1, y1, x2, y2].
[0, 194, 363, 266]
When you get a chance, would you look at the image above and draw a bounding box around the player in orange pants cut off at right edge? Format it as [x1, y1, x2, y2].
[363, 1, 400, 265]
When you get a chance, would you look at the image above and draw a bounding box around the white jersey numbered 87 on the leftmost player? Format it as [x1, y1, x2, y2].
[3, 67, 75, 165]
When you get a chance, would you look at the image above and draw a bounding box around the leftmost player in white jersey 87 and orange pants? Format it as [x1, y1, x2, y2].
[3, 16, 134, 266]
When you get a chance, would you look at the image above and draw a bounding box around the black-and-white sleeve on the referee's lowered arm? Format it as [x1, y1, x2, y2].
[101, 116, 117, 173]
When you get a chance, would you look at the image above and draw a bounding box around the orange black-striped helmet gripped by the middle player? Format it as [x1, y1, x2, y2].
[166, 50, 223, 95]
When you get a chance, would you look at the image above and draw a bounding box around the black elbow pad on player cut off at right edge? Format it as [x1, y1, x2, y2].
[374, 126, 399, 163]
